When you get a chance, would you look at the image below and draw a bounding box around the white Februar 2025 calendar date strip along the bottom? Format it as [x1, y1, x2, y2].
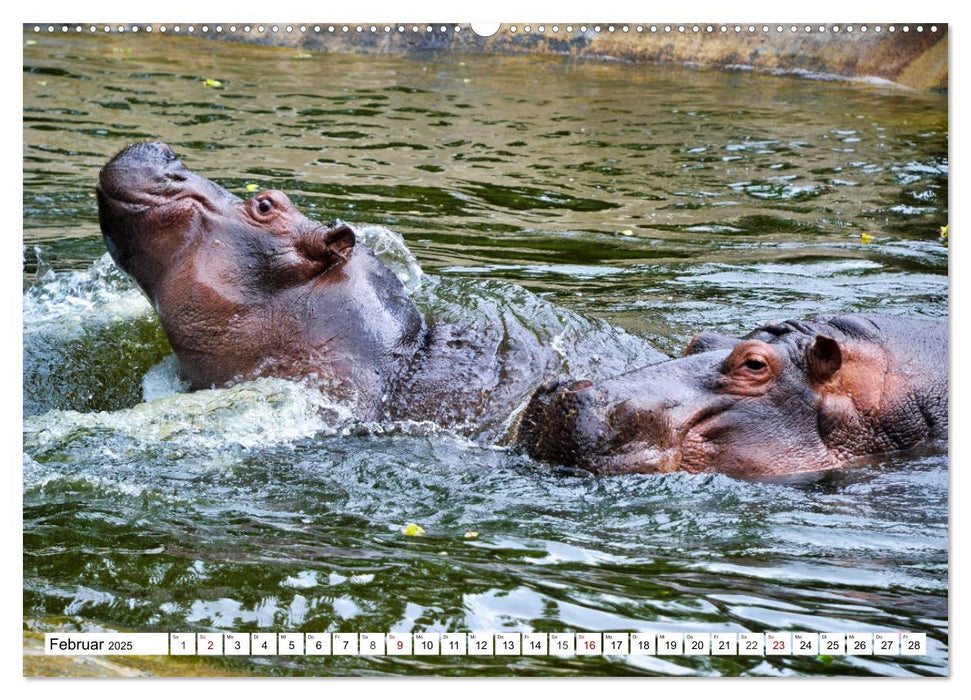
[44, 632, 927, 657]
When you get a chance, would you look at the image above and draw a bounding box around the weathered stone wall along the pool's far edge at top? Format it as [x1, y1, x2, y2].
[202, 23, 948, 92]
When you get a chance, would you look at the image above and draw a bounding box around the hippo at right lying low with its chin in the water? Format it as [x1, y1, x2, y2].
[518, 315, 948, 479]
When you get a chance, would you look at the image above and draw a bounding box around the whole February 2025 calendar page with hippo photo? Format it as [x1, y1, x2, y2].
[19, 5, 950, 690]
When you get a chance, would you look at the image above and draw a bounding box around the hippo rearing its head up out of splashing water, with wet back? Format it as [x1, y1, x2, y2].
[96, 142, 666, 439]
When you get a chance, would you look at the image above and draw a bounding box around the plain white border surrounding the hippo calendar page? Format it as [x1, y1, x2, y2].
[7, 0, 971, 700]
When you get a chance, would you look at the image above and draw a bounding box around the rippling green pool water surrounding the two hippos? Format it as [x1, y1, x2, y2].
[23, 33, 948, 675]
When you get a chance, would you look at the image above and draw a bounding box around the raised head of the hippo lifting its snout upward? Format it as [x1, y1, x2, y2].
[97, 143, 424, 404]
